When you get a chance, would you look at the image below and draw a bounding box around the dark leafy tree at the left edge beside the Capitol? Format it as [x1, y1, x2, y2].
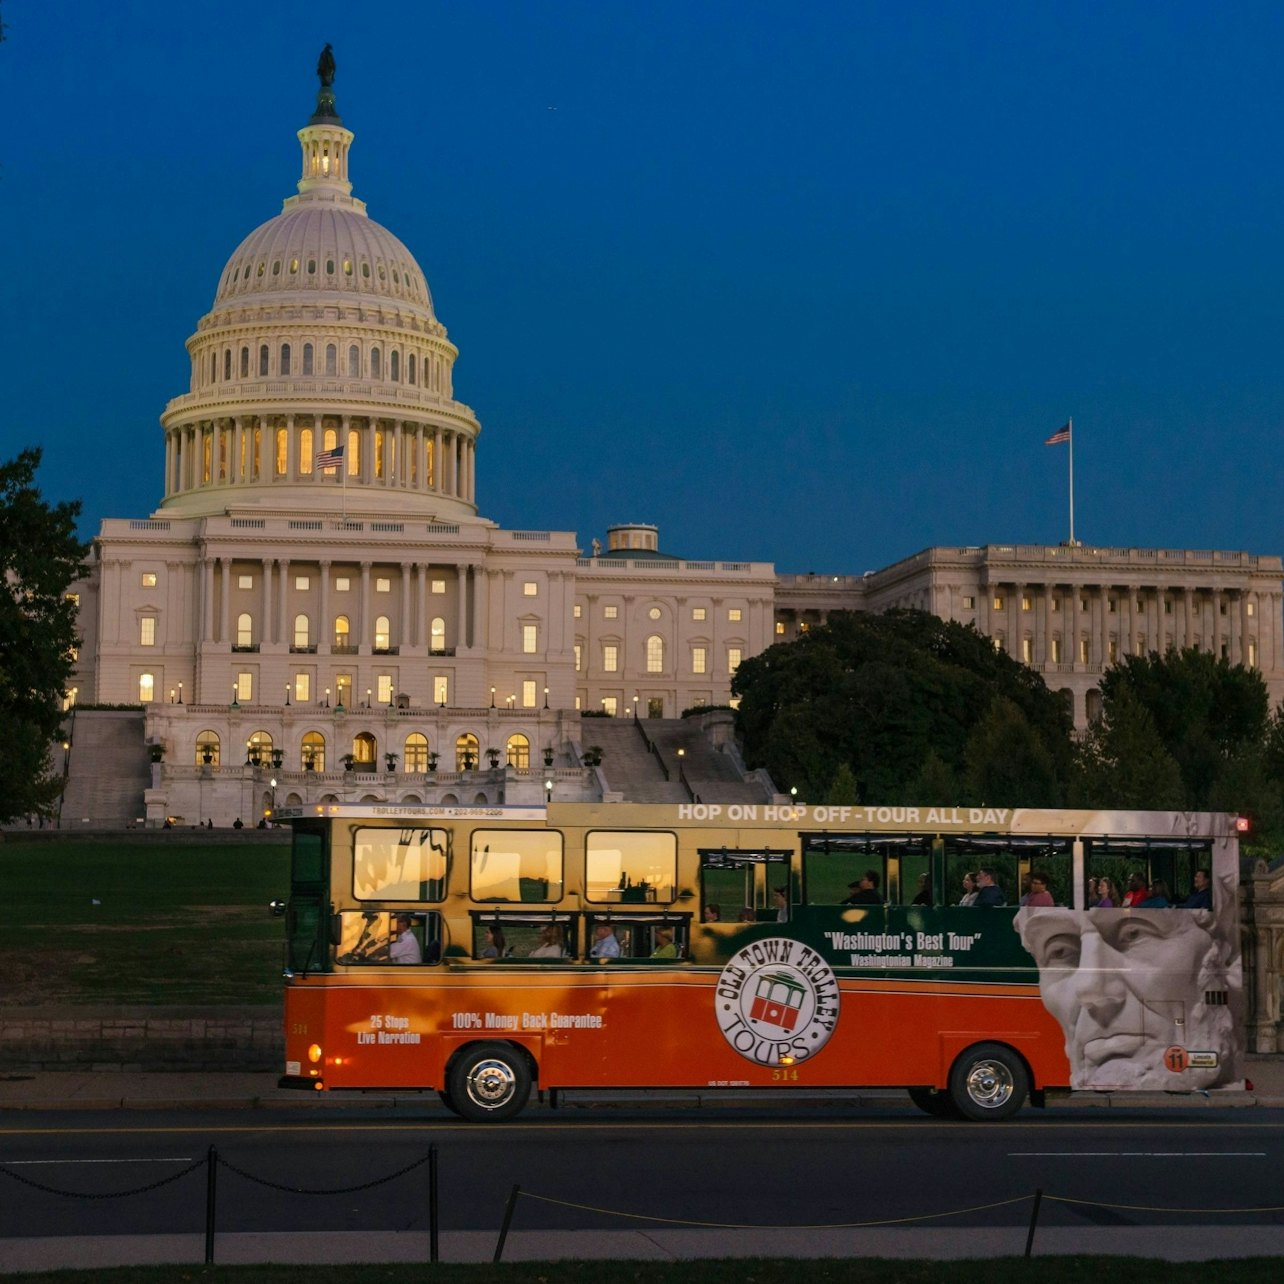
[0, 449, 89, 820]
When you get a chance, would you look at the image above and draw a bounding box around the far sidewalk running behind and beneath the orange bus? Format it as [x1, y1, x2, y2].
[0, 1054, 1284, 1118]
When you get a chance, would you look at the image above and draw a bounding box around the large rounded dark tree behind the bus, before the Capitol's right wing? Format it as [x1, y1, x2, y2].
[732, 610, 1071, 805]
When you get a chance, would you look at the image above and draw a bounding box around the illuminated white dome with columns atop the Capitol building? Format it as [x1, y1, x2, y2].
[161, 60, 480, 521]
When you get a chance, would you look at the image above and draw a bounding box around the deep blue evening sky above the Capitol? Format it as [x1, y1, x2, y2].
[0, 0, 1284, 573]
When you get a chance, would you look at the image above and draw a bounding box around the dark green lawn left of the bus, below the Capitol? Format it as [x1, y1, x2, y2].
[0, 837, 289, 1007]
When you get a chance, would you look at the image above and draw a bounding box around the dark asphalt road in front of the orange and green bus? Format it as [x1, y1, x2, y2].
[0, 1107, 1284, 1252]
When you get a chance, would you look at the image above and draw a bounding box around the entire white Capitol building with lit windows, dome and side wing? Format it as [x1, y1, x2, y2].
[64, 57, 1284, 826]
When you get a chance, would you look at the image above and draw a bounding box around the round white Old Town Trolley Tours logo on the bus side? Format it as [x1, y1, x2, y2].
[715, 936, 838, 1066]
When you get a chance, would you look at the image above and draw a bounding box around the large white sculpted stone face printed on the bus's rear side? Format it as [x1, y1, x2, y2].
[1014, 891, 1239, 1091]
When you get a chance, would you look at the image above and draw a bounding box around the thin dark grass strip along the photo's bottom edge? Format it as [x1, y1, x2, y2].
[5, 1254, 1280, 1284]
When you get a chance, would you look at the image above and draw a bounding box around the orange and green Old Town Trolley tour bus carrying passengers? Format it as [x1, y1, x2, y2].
[275, 803, 1244, 1120]
